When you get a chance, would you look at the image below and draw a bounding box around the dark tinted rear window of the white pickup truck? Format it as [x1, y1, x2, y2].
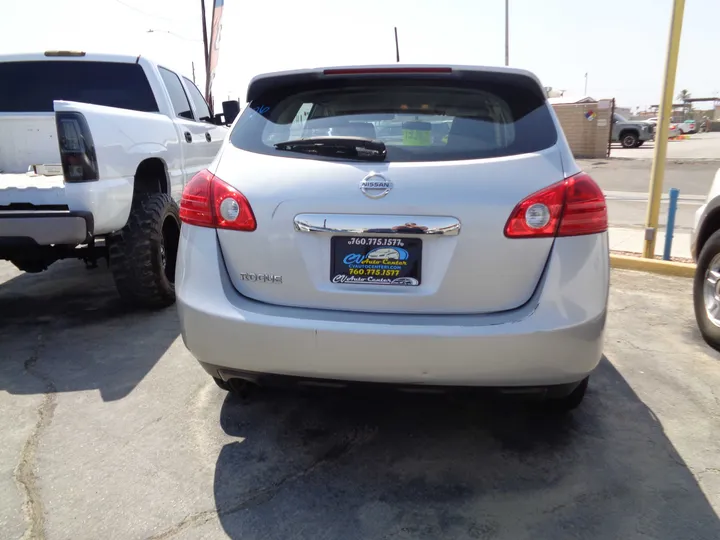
[0, 61, 158, 112]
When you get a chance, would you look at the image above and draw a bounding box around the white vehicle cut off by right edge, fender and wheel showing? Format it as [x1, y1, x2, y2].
[690, 170, 720, 350]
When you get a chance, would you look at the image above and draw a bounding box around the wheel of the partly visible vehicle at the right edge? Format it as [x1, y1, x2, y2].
[693, 231, 720, 350]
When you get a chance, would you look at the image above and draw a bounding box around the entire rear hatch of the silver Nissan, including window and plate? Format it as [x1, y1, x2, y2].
[214, 66, 564, 314]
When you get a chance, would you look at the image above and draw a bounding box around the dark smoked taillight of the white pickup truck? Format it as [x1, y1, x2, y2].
[55, 112, 99, 183]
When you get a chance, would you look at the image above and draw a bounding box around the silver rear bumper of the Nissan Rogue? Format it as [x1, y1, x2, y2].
[176, 225, 609, 387]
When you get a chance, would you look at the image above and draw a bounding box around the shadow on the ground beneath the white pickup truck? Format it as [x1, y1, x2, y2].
[0, 261, 179, 401]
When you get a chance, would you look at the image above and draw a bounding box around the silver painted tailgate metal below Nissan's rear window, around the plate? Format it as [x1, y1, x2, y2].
[215, 145, 565, 313]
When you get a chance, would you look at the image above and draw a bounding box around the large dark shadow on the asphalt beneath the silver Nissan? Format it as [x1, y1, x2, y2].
[214, 359, 720, 540]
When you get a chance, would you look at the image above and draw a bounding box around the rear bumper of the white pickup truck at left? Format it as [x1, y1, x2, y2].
[0, 210, 93, 248]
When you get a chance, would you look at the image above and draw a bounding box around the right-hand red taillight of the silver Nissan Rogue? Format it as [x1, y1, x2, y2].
[505, 173, 607, 238]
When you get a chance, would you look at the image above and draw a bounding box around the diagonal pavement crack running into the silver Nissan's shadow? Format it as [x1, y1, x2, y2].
[147, 426, 371, 540]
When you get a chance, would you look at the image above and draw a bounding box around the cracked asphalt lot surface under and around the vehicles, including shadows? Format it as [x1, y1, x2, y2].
[0, 261, 720, 540]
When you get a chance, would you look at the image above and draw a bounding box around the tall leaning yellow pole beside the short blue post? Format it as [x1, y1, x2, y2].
[643, 0, 685, 259]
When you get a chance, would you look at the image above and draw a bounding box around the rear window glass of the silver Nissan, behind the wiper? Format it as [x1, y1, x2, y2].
[231, 80, 557, 162]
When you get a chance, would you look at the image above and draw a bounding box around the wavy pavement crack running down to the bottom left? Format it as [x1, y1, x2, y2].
[14, 331, 57, 540]
